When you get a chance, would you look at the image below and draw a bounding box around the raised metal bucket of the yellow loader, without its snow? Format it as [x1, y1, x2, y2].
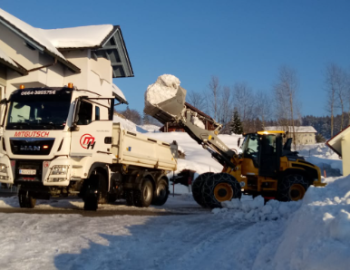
[144, 86, 186, 124]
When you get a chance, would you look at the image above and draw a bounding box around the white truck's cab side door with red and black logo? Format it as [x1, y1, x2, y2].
[71, 99, 112, 157]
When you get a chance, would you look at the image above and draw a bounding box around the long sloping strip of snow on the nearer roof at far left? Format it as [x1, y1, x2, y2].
[0, 8, 66, 60]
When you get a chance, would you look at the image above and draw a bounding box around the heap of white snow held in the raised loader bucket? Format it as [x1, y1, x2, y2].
[145, 74, 180, 110]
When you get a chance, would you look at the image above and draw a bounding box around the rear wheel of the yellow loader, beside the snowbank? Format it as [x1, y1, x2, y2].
[277, 173, 310, 202]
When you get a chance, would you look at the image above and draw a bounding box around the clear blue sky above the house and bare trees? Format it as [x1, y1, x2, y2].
[0, 0, 350, 116]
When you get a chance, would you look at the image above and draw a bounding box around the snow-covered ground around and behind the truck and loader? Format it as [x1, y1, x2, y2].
[0, 122, 350, 270]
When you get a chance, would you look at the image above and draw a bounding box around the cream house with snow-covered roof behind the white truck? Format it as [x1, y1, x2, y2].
[0, 9, 134, 103]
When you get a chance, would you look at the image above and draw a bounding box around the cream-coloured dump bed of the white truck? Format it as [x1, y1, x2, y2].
[111, 123, 177, 171]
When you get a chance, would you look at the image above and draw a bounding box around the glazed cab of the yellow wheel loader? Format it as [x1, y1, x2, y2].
[242, 131, 284, 177]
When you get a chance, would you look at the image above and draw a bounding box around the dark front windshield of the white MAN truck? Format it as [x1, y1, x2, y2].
[6, 91, 71, 130]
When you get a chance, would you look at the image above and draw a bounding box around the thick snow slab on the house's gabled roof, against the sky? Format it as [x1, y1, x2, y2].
[41, 24, 114, 49]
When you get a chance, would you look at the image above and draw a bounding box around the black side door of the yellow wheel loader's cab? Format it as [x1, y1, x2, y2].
[259, 134, 282, 177]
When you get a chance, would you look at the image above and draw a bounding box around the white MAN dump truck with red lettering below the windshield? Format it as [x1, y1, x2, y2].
[0, 84, 177, 210]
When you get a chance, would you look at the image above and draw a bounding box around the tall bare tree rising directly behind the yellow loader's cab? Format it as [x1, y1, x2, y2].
[274, 66, 299, 147]
